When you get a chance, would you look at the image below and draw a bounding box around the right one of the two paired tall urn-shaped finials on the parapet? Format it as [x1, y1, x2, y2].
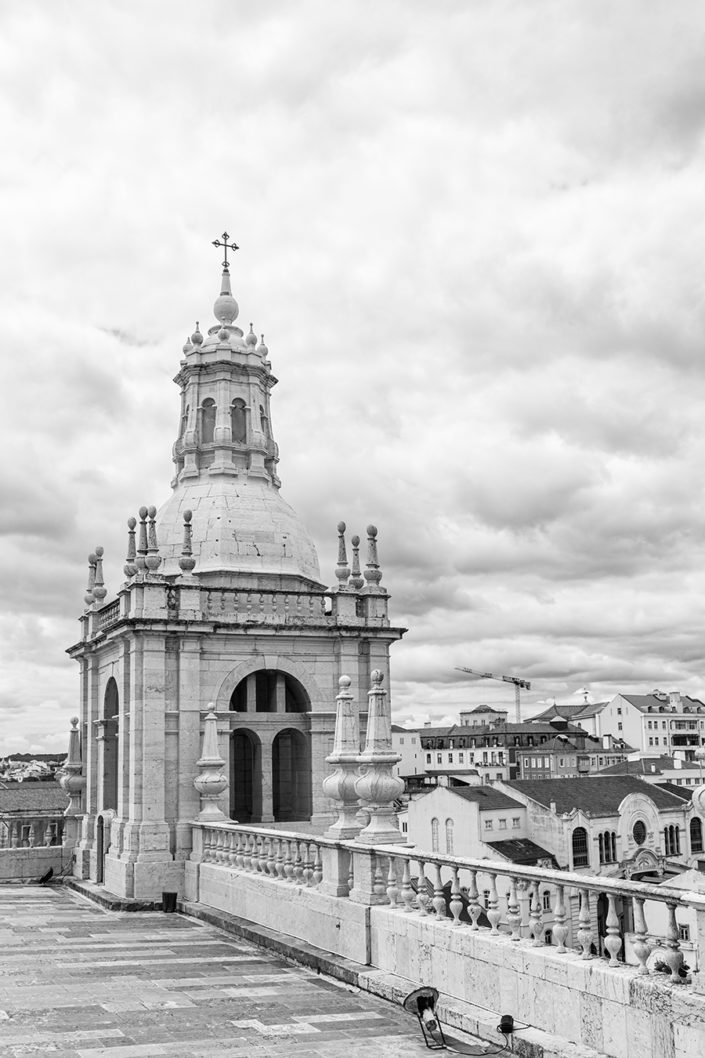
[355, 669, 406, 844]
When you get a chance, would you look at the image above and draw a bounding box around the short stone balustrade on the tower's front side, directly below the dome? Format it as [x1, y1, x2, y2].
[203, 588, 335, 625]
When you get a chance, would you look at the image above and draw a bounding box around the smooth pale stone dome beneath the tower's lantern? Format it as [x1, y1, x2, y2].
[157, 476, 321, 585]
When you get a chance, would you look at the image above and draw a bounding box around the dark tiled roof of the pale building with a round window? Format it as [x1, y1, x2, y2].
[505, 776, 681, 816]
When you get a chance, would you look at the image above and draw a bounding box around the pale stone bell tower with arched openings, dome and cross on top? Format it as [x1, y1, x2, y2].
[69, 242, 404, 900]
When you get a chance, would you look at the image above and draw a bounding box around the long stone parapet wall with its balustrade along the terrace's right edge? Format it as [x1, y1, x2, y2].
[186, 823, 705, 1058]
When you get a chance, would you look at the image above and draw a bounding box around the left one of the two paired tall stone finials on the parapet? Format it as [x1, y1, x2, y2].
[322, 676, 360, 841]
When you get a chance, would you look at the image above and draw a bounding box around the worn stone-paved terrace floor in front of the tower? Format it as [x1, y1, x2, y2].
[0, 886, 485, 1058]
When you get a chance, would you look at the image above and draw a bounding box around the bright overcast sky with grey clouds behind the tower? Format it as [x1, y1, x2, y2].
[0, 0, 705, 753]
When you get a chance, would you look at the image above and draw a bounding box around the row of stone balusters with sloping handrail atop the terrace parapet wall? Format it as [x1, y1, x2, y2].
[197, 823, 705, 984]
